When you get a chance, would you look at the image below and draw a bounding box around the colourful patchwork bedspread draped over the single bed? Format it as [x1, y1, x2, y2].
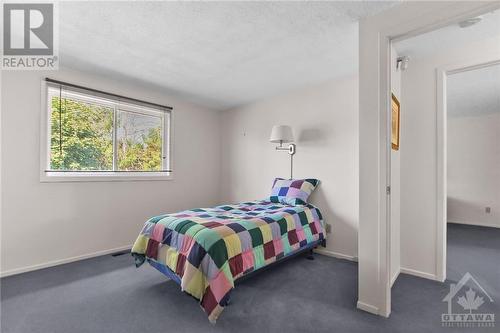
[132, 201, 325, 322]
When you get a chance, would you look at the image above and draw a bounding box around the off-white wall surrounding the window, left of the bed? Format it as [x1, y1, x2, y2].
[1, 70, 220, 275]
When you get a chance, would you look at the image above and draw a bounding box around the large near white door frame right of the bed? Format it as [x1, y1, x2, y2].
[357, 1, 500, 317]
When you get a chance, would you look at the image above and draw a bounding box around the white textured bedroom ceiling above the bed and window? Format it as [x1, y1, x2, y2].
[60, 1, 397, 109]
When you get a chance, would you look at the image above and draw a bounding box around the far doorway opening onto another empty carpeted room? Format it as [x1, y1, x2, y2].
[438, 59, 500, 288]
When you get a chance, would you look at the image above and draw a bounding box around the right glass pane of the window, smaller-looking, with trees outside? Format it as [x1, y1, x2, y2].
[116, 110, 163, 171]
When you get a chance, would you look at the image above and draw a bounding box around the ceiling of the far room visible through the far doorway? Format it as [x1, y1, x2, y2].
[447, 64, 500, 117]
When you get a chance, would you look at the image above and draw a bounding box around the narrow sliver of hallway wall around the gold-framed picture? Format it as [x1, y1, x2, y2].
[390, 46, 404, 284]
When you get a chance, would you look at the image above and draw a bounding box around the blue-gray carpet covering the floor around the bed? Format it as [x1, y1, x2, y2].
[1, 225, 500, 333]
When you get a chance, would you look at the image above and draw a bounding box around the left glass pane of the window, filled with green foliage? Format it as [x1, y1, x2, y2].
[50, 95, 113, 171]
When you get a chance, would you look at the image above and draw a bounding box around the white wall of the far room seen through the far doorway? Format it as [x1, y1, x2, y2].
[447, 113, 500, 228]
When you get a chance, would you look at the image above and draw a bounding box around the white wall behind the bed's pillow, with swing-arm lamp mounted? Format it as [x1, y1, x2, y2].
[221, 77, 358, 258]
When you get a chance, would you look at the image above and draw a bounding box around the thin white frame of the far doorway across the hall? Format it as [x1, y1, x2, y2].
[436, 55, 500, 282]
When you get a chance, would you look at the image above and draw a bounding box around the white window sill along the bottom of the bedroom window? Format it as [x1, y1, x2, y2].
[40, 171, 174, 183]
